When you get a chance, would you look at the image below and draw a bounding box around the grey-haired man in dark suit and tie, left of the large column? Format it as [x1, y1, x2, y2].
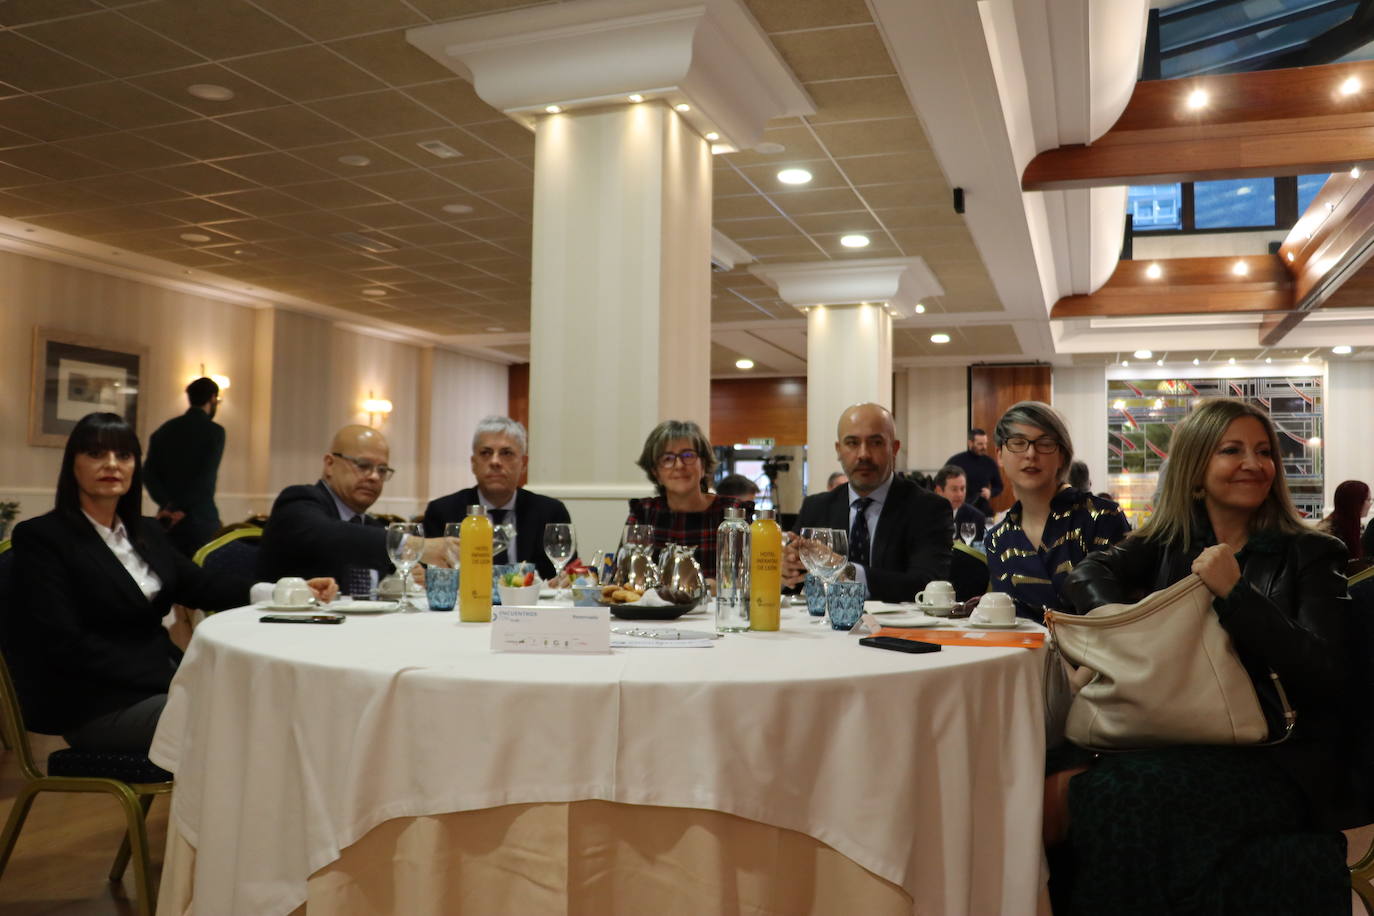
[425, 416, 573, 578]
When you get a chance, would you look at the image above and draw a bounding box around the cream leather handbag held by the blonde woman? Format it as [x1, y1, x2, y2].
[1046, 575, 1297, 750]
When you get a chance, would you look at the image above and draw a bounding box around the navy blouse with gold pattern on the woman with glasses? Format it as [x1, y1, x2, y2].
[984, 488, 1131, 623]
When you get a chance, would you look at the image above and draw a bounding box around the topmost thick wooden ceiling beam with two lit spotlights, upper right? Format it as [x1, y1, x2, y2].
[1021, 60, 1374, 191]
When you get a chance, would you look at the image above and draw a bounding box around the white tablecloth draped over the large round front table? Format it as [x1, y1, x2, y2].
[151, 608, 1043, 916]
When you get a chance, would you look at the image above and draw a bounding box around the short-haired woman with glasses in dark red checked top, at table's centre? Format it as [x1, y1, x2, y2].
[625, 420, 754, 578]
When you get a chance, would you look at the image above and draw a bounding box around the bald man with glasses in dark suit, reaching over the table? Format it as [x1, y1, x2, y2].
[258, 426, 448, 595]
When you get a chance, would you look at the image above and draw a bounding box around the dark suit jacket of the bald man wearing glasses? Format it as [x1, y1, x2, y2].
[258, 481, 394, 582]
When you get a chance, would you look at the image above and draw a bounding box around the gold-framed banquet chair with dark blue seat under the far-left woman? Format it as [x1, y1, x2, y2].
[0, 650, 172, 916]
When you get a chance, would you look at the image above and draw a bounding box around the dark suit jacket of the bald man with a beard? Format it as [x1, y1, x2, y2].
[793, 478, 954, 602]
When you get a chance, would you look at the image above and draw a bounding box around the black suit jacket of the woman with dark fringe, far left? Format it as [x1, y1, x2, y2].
[0, 511, 253, 735]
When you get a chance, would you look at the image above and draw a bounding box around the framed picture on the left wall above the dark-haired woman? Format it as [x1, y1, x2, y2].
[29, 327, 148, 448]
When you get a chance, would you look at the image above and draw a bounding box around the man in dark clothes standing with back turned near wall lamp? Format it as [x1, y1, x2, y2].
[143, 378, 224, 556]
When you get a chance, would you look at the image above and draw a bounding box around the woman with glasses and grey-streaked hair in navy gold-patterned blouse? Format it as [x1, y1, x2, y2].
[985, 401, 1131, 623]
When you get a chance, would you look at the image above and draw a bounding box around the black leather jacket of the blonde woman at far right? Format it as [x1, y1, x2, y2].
[1065, 525, 1356, 827]
